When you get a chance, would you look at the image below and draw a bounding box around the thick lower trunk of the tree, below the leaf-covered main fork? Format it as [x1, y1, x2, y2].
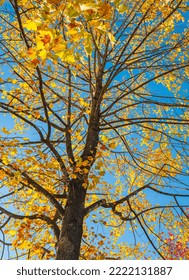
[56, 179, 86, 260]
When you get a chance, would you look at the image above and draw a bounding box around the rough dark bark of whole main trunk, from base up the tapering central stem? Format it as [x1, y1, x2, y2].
[56, 71, 102, 260]
